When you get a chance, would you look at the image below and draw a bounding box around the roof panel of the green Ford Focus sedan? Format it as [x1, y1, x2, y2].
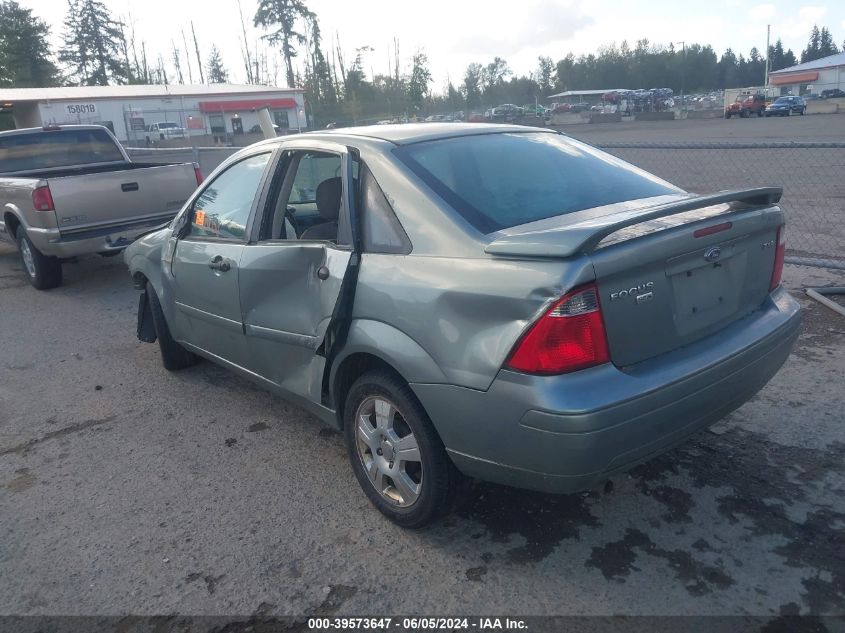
[294, 123, 558, 145]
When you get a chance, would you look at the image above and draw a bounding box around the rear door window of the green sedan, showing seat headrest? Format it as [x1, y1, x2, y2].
[259, 151, 343, 242]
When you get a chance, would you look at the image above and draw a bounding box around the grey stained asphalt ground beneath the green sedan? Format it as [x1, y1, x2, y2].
[0, 236, 845, 630]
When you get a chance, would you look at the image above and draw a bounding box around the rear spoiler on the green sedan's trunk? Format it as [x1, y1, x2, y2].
[484, 187, 783, 257]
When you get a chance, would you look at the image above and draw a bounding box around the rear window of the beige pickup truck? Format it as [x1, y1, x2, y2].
[0, 129, 124, 173]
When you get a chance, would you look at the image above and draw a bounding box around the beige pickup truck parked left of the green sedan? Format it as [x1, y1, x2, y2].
[0, 125, 202, 290]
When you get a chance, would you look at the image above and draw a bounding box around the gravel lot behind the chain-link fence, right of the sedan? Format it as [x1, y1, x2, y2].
[560, 114, 845, 268]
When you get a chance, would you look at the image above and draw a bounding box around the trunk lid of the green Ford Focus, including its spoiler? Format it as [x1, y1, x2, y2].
[486, 188, 783, 367]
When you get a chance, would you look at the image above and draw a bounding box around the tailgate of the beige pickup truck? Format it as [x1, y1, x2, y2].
[47, 163, 197, 235]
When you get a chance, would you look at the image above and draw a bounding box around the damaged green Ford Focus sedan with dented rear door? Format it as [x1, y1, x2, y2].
[125, 123, 800, 527]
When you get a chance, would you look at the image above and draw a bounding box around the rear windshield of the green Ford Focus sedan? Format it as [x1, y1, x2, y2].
[396, 132, 681, 233]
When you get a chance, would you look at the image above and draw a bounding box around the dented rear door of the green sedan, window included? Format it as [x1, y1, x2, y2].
[239, 141, 354, 403]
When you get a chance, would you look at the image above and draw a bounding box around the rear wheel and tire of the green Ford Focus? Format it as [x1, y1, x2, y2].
[343, 370, 463, 529]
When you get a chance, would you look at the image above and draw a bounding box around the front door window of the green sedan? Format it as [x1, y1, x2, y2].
[188, 152, 270, 240]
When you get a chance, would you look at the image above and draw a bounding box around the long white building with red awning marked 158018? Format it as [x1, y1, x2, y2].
[0, 84, 307, 145]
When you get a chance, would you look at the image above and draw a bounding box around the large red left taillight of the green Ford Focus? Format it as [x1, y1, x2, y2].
[506, 284, 610, 374]
